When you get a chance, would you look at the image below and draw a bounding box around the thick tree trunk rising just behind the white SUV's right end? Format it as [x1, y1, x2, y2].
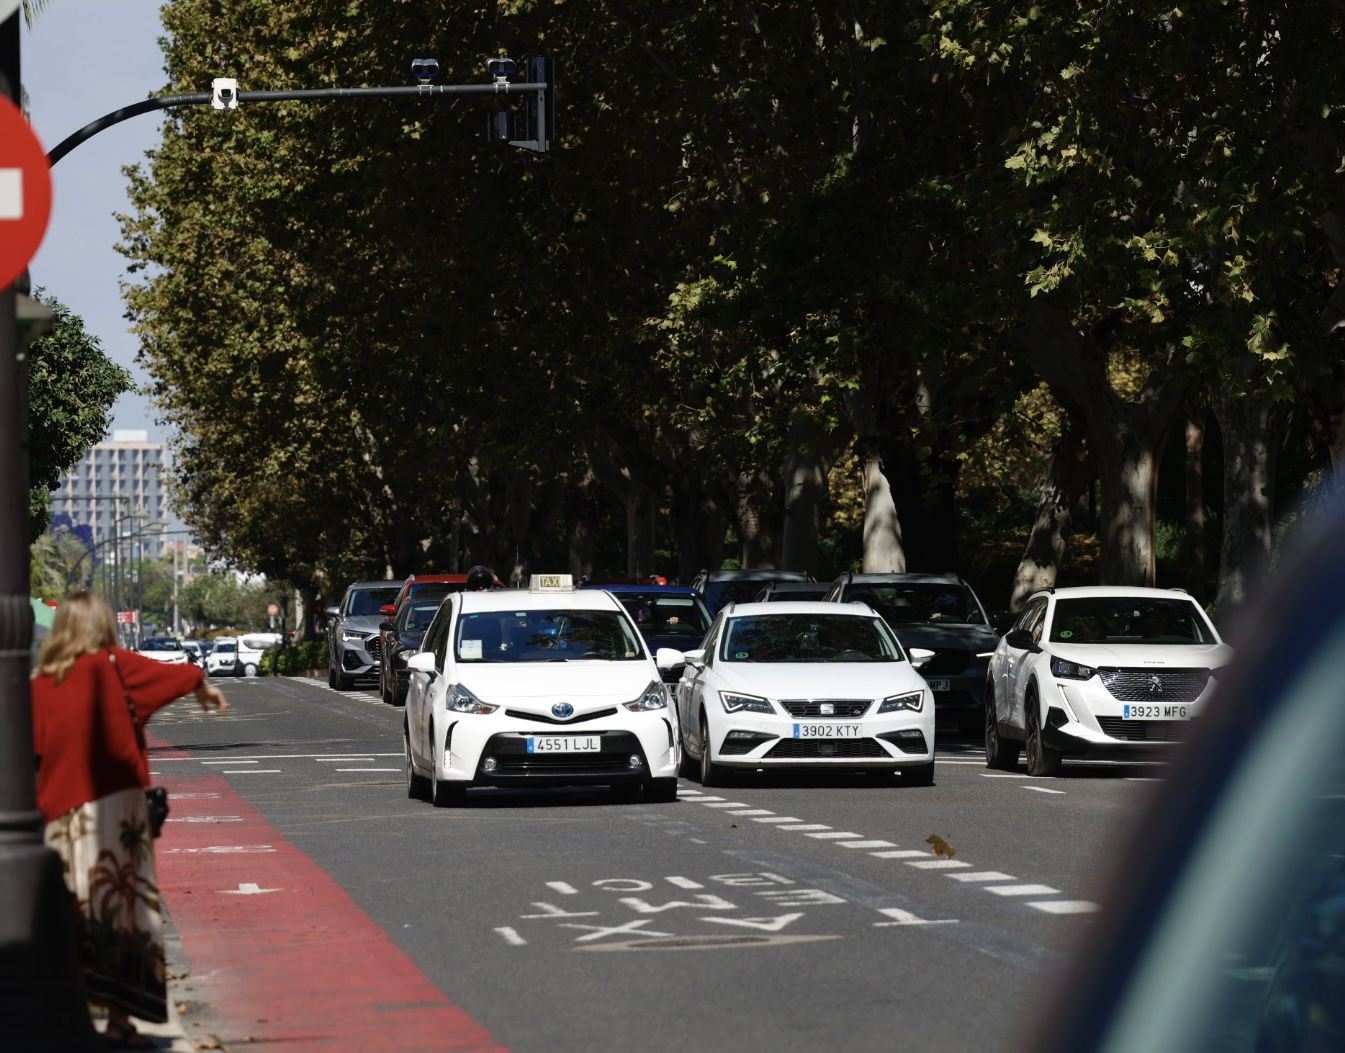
[1215, 390, 1275, 623]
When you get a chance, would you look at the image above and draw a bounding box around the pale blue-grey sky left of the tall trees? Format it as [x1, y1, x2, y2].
[20, 0, 169, 441]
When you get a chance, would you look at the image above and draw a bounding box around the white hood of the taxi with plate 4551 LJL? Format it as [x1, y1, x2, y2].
[459, 659, 659, 713]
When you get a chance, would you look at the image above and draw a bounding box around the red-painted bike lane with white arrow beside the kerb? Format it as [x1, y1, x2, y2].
[148, 736, 504, 1053]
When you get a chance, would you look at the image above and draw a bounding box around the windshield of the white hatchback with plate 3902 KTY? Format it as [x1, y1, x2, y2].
[720, 615, 901, 662]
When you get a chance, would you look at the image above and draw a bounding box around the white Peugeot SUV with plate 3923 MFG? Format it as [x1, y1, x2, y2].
[986, 586, 1232, 776]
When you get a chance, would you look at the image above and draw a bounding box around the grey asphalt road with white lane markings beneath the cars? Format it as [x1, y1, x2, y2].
[151, 679, 1161, 1053]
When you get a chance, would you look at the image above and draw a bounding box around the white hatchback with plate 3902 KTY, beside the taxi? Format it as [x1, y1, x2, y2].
[658, 601, 933, 785]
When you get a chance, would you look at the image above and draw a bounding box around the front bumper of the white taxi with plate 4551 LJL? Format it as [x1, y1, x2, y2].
[434, 707, 682, 785]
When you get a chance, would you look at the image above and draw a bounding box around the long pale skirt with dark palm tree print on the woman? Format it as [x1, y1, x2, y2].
[46, 787, 168, 1023]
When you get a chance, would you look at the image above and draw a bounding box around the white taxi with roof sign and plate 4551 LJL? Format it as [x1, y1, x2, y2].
[404, 574, 681, 806]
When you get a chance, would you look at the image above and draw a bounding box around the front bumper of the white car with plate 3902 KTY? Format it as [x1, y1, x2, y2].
[709, 710, 935, 769]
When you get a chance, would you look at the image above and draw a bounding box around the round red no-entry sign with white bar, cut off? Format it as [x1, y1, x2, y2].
[0, 95, 51, 289]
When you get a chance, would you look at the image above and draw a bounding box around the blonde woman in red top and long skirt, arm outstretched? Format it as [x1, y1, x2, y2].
[32, 592, 229, 1049]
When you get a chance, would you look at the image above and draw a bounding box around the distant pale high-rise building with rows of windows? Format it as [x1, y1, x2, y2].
[51, 430, 169, 559]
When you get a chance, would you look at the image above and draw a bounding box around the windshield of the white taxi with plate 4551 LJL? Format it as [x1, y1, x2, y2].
[455, 609, 644, 662]
